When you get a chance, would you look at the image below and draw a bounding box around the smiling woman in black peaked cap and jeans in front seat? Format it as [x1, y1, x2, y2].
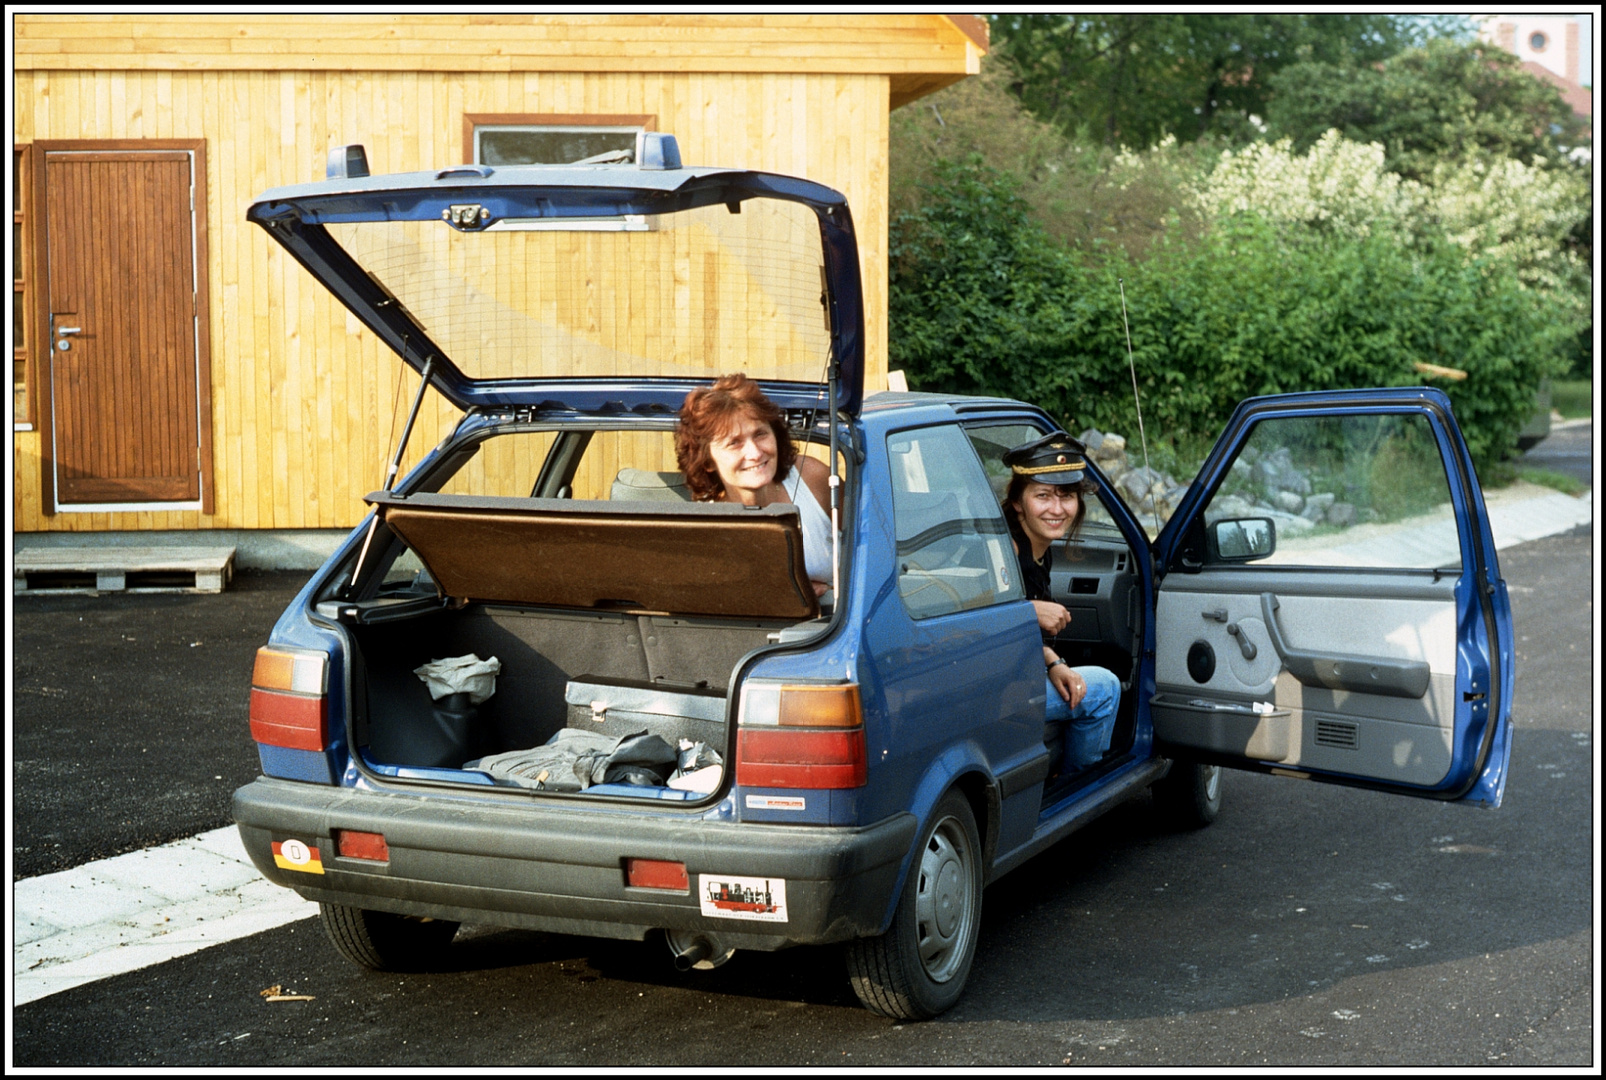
[1004, 434, 1121, 771]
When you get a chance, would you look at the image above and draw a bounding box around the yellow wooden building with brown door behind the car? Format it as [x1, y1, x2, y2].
[13, 13, 986, 534]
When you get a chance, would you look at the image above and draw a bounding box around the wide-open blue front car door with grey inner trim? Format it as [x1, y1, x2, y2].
[1152, 389, 1513, 807]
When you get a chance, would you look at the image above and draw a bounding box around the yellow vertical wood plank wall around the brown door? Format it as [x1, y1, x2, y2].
[13, 69, 890, 532]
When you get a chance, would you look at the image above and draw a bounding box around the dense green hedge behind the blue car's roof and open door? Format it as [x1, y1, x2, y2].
[890, 162, 1566, 466]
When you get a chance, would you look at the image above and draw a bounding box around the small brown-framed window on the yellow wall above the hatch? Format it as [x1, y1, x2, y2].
[463, 113, 657, 166]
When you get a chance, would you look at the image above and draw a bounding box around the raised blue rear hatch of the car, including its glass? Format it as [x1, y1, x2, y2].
[247, 154, 864, 416]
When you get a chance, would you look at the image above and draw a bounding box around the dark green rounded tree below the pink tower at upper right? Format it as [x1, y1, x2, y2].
[1266, 40, 1580, 182]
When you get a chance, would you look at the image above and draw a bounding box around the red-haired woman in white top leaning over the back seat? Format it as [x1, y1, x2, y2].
[675, 373, 830, 596]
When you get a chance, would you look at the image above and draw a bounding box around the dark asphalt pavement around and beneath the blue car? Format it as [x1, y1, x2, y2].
[10, 421, 1598, 1067]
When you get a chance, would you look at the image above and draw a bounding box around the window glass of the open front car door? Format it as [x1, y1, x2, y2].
[1205, 415, 1461, 569]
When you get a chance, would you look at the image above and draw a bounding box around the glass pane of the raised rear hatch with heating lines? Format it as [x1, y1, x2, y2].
[326, 199, 830, 383]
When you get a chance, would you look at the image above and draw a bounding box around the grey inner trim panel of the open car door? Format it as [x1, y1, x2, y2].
[1153, 571, 1455, 786]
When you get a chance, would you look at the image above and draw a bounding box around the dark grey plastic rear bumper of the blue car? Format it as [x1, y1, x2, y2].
[234, 776, 917, 948]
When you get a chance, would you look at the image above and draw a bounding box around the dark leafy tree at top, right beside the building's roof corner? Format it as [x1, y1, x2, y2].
[991, 14, 1458, 148]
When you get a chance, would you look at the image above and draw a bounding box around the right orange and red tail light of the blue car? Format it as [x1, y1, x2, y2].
[736, 680, 867, 789]
